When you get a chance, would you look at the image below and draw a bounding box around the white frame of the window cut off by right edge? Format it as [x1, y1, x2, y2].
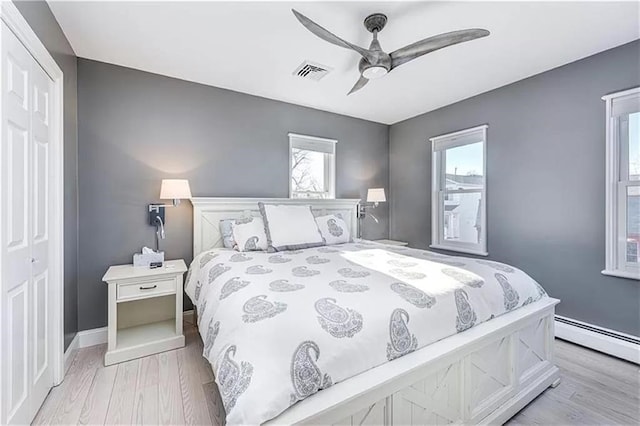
[602, 87, 640, 280]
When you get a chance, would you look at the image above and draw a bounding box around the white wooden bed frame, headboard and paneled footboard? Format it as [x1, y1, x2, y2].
[192, 198, 560, 425]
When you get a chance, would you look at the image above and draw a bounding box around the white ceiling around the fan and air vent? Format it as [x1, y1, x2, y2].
[49, 1, 640, 124]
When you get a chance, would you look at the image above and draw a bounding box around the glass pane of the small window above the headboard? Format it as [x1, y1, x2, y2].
[291, 148, 328, 198]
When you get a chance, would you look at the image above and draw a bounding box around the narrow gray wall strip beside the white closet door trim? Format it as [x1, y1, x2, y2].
[14, 1, 78, 349]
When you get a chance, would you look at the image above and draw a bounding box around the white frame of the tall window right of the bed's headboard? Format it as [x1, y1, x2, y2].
[429, 124, 489, 256]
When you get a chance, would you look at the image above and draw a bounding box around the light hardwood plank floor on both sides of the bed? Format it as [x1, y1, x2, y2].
[34, 324, 640, 425]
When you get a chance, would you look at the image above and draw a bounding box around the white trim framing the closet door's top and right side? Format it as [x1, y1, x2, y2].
[0, 1, 64, 386]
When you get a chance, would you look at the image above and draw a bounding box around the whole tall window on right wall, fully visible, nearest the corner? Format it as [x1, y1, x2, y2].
[430, 125, 488, 256]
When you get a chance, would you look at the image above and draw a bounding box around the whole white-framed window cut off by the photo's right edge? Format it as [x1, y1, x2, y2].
[602, 87, 640, 279]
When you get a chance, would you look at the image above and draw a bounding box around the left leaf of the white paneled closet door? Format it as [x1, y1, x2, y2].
[0, 24, 33, 423]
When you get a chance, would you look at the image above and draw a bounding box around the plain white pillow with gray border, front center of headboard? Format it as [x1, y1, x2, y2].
[258, 203, 325, 252]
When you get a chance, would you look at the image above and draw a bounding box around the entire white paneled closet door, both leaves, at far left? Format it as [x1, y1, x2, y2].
[0, 23, 53, 424]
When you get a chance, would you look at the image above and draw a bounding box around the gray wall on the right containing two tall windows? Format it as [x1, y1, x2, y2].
[389, 41, 640, 335]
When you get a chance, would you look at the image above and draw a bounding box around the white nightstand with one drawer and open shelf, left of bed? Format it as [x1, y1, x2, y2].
[102, 259, 187, 365]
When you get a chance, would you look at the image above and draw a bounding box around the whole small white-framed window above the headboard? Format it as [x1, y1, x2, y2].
[289, 133, 337, 198]
